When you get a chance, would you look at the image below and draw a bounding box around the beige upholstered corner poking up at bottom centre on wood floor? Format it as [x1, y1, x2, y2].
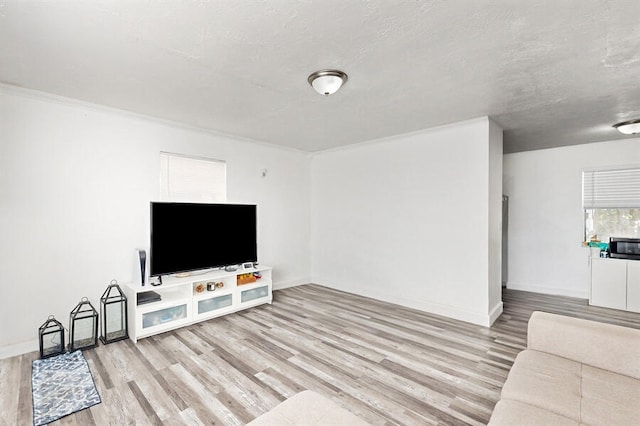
[247, 390, 369, 426]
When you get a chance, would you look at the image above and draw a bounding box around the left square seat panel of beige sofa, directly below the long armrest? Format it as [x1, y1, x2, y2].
[501, 349, 581, 420]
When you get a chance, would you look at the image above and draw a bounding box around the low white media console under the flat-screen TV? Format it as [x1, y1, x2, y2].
[123, 265, 273, 343]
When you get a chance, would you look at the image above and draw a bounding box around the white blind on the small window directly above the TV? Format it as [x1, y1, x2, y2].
[160, 152, 227, 203]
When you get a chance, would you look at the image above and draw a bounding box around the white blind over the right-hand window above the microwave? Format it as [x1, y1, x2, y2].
[582, 168, 640, 209]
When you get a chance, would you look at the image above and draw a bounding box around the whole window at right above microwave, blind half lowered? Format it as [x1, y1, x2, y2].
[582, 168, 640, 241]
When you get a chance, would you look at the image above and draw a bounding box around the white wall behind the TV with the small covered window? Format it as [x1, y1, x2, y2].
[0, 88, 310, 357]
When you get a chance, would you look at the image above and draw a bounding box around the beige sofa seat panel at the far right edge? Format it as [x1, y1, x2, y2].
[581, 360, 640, 425]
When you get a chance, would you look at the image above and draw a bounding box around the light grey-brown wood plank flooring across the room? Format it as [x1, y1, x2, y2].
[0, 285, 640, 425]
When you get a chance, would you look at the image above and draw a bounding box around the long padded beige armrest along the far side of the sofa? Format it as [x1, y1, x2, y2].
[527, 312, 640, 379]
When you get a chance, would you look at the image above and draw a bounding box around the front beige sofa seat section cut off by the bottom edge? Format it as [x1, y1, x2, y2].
[487, 399, 580, 426]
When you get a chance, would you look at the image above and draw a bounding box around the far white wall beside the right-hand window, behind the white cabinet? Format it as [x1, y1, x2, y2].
[503, 138, 640, 298]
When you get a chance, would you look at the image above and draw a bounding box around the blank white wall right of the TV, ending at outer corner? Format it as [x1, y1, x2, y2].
[311, 118, 502, 325]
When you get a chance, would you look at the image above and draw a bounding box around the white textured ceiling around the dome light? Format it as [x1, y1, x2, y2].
[0, 0, 640, 152]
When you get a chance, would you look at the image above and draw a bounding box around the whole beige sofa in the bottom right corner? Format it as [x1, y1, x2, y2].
[489, 312, 640, 426]
